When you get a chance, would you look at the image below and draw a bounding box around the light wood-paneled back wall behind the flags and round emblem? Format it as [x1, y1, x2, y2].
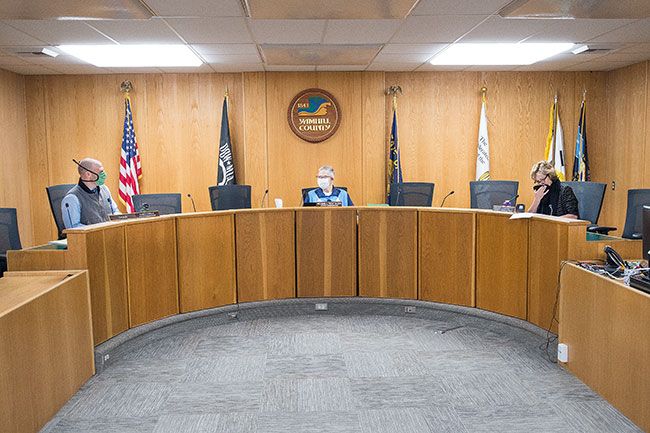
[10, 62, 650, 244]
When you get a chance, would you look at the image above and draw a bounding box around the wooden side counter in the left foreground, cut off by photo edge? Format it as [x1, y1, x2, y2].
[0, 271, 95, 433]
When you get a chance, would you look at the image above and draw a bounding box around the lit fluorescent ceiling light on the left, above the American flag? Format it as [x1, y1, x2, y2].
[58, 45, 203, 68]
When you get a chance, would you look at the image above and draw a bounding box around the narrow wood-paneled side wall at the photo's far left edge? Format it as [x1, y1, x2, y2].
[0, 70, 32, 245]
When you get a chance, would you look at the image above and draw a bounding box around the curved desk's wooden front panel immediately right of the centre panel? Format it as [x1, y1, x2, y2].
[358, 207, 418, 299]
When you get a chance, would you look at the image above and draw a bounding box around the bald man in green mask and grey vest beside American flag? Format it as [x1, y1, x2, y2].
[61, 158, 120, 229]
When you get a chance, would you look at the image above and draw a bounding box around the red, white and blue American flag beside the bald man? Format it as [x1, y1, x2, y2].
[120, 96, 142, 213]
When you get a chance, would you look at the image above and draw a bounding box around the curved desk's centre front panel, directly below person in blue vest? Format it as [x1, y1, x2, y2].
[296, 208, 357, 298]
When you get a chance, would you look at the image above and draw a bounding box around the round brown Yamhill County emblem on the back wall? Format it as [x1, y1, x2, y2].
[287, 89, 341, 143]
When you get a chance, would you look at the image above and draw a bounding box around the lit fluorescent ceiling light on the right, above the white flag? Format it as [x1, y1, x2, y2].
[430, 43, 573, 65]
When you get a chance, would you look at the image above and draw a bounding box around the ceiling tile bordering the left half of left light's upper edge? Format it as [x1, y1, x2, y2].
[5, 20, 112, 45]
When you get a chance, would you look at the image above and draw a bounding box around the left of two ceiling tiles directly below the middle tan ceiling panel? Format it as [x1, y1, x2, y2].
[249, 20, 325, 45]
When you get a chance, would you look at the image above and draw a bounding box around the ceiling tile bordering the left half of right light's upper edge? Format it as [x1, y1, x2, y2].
[459, 16, 550, 42]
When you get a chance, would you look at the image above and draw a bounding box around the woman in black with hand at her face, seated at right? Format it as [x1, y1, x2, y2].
[528, 161, 580, 219]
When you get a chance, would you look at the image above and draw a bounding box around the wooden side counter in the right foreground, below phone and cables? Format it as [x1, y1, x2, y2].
[559, 265, 650, 431]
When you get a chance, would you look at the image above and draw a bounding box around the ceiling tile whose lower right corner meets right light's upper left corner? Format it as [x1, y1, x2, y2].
[390, 15, 485, 44]
